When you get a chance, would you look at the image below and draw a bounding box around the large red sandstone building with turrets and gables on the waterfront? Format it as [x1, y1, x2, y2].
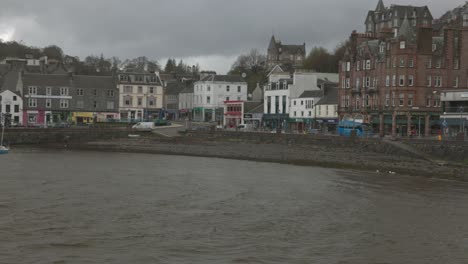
[339, 0, 468, 136]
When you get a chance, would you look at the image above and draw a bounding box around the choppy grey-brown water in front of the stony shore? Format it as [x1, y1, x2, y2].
[0, 150, 468, 263]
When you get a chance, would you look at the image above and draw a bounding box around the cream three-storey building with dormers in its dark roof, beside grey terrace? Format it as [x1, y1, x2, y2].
[118, 72, 164, 120]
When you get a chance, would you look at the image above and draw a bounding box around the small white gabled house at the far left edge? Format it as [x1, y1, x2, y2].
[0, 90, 23, 126]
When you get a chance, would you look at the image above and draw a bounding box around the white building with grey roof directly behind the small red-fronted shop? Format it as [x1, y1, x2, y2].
[193, 74, 247, 123]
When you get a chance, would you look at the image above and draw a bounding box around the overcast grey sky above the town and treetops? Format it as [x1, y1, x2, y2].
[0, 0, 465, 73]
